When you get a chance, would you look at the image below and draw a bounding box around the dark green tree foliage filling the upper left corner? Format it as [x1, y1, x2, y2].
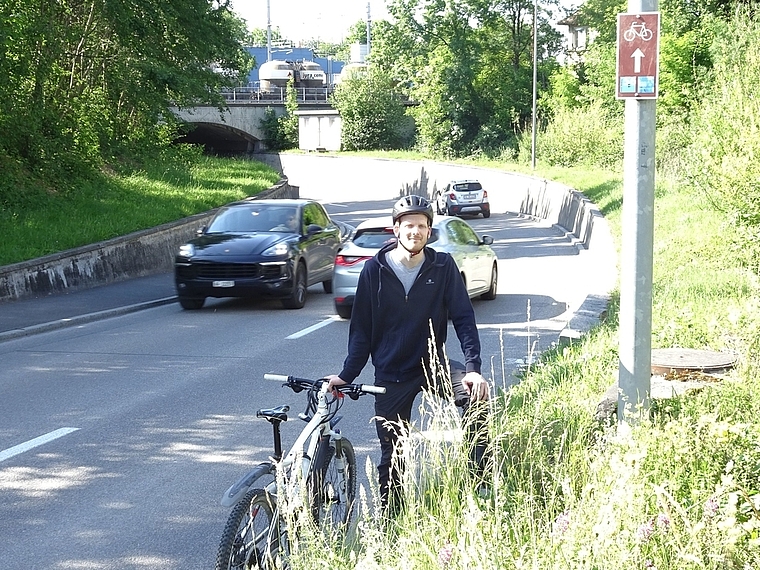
[0, 0, 250, 191]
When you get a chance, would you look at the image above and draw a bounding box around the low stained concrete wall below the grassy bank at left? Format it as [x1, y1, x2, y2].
[0, 179, 298, 303]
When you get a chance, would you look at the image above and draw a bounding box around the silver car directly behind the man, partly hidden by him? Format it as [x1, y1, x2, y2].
[332, 216, 499, 319]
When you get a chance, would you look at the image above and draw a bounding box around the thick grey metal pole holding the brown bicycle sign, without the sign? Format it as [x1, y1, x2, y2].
[618, 0, 658, 426]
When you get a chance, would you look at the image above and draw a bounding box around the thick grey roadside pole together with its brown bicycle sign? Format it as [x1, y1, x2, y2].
[616, 0, 660, 426]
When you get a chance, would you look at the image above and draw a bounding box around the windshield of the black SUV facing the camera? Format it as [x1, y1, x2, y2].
[207, 204, 299, 234]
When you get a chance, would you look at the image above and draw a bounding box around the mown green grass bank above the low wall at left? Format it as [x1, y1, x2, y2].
[0, 154, 279, 265]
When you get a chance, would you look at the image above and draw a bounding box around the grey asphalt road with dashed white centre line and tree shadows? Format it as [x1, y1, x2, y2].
[0, 197, 594, 570]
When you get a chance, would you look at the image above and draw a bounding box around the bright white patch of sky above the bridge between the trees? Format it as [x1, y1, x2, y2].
[232, 0, 388, 43]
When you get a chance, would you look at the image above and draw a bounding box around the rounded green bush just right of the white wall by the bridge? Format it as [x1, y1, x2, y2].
[333, 68, 409, 151]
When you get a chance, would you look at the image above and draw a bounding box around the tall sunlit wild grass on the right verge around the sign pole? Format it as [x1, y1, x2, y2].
[280, 161, 760, 570]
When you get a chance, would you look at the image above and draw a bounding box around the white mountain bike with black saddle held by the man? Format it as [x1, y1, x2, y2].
[215, 374, 385, 570]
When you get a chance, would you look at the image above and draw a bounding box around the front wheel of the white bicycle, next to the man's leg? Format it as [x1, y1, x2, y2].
[309, 439, 357, 532]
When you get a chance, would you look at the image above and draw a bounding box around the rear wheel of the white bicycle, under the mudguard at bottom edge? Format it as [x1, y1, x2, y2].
[214, 489, 281, 570]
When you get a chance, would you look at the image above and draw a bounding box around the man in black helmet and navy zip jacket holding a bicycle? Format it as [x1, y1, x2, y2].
[328, 195, 489, 509]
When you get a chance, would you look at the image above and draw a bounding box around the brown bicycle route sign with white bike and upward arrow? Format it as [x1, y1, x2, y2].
[617, 12, 660, 99]
